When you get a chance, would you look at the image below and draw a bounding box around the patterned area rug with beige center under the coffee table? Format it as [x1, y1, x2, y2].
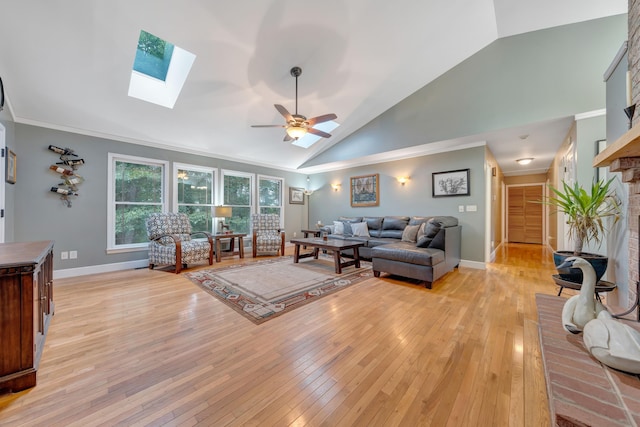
[184, 256, 373, 324]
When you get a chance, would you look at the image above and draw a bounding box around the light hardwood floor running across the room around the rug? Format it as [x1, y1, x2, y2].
[0, 244, 557, 426]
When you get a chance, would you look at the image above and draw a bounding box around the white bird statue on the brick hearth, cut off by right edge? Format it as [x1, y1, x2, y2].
[582, 311, 640, 374]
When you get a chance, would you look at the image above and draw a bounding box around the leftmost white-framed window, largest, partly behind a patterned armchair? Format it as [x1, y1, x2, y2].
[107, 153, 169, 253]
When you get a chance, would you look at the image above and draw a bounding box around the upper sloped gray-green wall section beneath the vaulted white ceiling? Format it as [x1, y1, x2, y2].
[304, 15, 627, 166]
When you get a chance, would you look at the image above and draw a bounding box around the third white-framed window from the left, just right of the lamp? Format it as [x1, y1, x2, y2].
[222, 169, 253, 234]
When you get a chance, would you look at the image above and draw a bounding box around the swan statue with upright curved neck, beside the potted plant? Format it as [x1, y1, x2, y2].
[557, 257, 607, 334]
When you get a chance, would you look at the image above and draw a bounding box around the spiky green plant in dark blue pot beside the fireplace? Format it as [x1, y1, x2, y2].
[544, 178, 621, 283]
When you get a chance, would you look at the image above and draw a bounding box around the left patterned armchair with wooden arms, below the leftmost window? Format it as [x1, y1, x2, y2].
[146, 213, 213, 274]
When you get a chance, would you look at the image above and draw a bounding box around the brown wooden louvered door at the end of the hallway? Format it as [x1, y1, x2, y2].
[507, 184, 543, 244]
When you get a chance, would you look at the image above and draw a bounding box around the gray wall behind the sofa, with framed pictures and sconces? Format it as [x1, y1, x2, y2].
[309, 146, 487, 263]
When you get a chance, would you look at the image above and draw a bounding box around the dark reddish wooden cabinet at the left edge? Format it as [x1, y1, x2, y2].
[0, 241, 53, 392]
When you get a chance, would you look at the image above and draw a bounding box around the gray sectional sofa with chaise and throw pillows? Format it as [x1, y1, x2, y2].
[322, 216, 462, 289]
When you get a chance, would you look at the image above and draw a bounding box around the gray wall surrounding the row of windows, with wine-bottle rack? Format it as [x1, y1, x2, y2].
[7, 124, 308, 270]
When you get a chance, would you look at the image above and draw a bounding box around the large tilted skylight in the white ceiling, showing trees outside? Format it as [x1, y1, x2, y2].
[129, 31, 196, 108]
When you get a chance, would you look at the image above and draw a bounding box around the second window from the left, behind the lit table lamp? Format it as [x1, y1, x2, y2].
[173, 163, 216, 233]
